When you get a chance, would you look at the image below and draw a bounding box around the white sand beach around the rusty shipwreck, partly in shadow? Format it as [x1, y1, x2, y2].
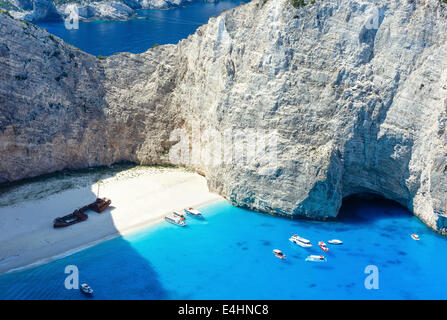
[0, 167, 223, 273]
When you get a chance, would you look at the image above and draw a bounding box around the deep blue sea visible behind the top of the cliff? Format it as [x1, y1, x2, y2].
[38, 0, 247, 56]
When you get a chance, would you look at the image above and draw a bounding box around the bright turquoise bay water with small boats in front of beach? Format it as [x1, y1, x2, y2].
[0, 200, 447, 299]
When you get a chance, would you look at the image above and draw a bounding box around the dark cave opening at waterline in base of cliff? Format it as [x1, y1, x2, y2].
[337, 193, 412, 223]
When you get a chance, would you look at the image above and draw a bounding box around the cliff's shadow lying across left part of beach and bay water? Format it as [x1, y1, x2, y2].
[0, 163, 168, 300]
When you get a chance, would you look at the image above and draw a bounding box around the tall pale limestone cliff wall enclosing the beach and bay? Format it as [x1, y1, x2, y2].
[0, 0, 447, 232]
